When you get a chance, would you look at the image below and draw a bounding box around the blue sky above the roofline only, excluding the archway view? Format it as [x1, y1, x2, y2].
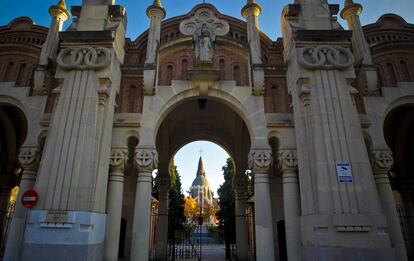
[0, 0, 414, 40]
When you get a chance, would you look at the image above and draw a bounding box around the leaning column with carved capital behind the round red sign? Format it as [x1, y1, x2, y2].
[4, 147, 39, 261]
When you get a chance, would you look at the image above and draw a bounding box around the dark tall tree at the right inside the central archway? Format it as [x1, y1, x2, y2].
[217, 159, 236, 260]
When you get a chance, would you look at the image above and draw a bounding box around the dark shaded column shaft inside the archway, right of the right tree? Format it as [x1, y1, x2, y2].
[233, 174, 249, 261]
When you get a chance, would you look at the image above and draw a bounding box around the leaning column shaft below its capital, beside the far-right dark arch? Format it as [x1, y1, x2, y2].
[374, 172, 407, 261]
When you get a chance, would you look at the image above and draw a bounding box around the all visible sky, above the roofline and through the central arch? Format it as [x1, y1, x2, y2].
[0, 0, 414, 195]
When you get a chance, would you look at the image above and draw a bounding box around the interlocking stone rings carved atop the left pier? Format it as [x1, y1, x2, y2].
[57, 47, 111, 70]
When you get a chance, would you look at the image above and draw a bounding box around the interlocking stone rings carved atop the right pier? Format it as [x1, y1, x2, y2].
[298, 46, 354, 70]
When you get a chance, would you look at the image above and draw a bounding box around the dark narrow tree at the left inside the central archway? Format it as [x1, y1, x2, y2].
[168, 161, 185, 239]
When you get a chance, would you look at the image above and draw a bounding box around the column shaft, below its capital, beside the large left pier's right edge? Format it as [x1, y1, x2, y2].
[104, 170, 124, 261]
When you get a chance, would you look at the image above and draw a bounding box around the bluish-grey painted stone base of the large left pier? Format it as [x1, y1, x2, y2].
[21, 211, 106, 261]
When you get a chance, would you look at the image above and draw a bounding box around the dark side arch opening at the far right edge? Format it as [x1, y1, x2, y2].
[384, 103, 414, 260]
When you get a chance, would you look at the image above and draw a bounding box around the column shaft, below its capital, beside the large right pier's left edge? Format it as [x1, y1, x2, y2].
[283, 171, 302, 261]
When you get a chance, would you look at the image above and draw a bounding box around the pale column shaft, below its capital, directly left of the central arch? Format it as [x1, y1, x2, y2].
[131, 172, 152, 261]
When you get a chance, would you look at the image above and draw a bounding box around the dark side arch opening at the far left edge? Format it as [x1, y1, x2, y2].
[0, 104, 27, 257]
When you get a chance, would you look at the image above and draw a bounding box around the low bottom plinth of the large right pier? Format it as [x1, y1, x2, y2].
[302, 247, 396, 261]
